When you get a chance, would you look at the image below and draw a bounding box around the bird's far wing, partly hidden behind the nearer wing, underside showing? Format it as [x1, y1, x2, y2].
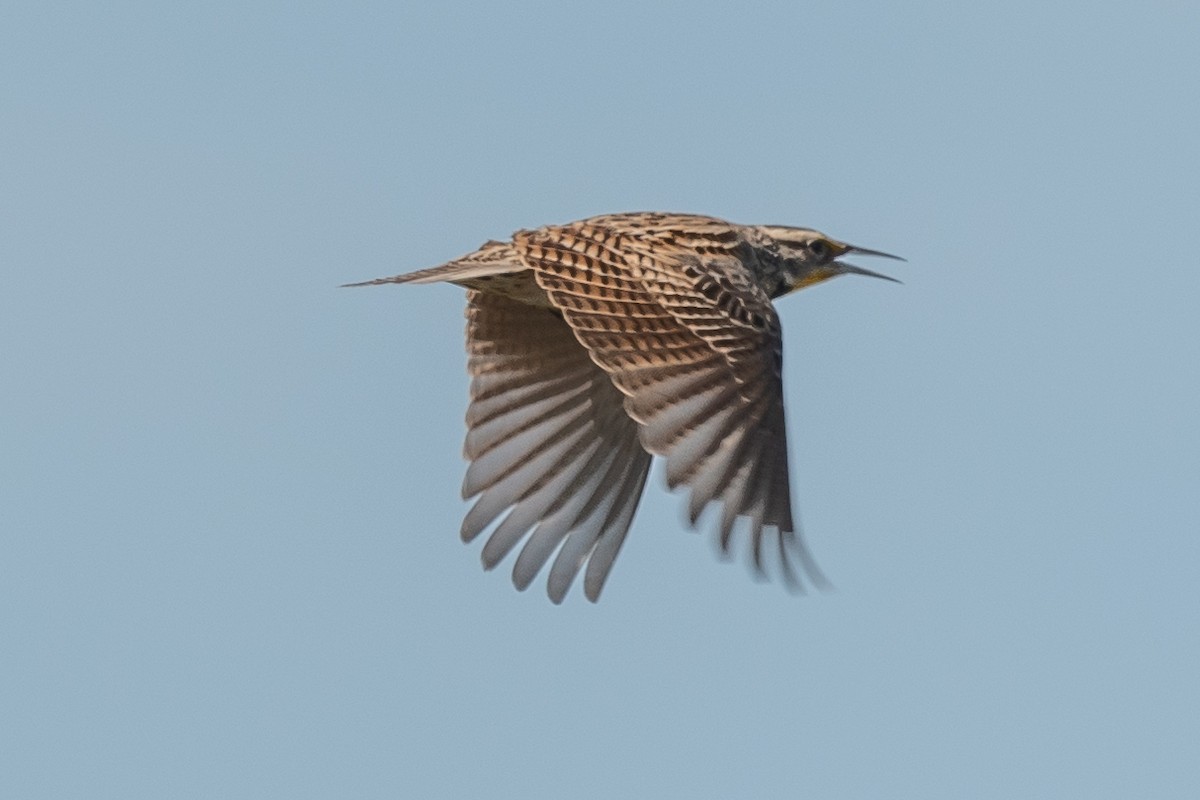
[462, 290, 650, 603]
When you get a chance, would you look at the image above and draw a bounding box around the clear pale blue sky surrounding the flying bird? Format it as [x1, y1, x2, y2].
[0, 1, 1200, 799]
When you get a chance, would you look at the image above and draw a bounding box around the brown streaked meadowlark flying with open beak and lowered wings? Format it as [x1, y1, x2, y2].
[348, 212, 902, 603]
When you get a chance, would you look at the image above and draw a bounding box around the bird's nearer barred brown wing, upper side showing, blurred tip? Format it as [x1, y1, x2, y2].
[514, 221, 824, 588]
